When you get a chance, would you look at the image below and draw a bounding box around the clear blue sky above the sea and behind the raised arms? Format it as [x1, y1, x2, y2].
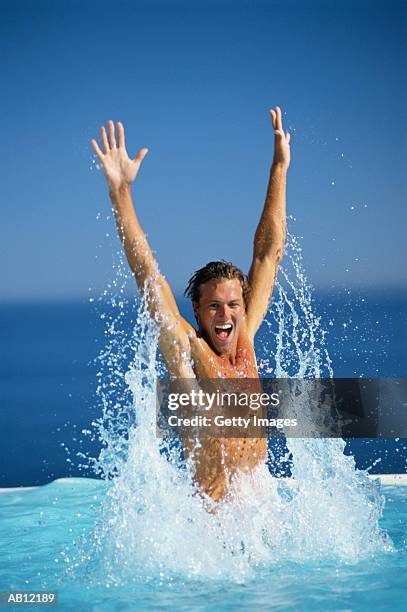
[0, 0, 407, 301]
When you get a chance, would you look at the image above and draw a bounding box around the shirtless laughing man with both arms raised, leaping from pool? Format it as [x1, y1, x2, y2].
[92, 106, 290, 501]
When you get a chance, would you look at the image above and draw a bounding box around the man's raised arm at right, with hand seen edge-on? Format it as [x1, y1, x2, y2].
[247, 106, 290, 340]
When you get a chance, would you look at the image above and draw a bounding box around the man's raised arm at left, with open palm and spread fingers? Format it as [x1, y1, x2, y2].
[92, 121, 194, 377]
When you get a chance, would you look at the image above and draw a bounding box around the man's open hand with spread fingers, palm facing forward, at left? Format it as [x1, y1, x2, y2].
[92, 121, 148, 192]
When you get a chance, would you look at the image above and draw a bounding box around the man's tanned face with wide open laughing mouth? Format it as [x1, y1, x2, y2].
[193, 278, 245, 355]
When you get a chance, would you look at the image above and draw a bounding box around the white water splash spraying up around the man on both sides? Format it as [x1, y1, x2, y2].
[73, 235, 392, 585]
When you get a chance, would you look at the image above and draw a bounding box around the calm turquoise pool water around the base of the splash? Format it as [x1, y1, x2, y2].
[0, 478, 407, 611]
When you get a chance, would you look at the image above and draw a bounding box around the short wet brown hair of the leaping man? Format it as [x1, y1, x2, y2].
[184, 260, 250, 307]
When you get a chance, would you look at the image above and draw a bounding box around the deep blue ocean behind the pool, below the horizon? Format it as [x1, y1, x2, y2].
[0, 290, 407, 487]
